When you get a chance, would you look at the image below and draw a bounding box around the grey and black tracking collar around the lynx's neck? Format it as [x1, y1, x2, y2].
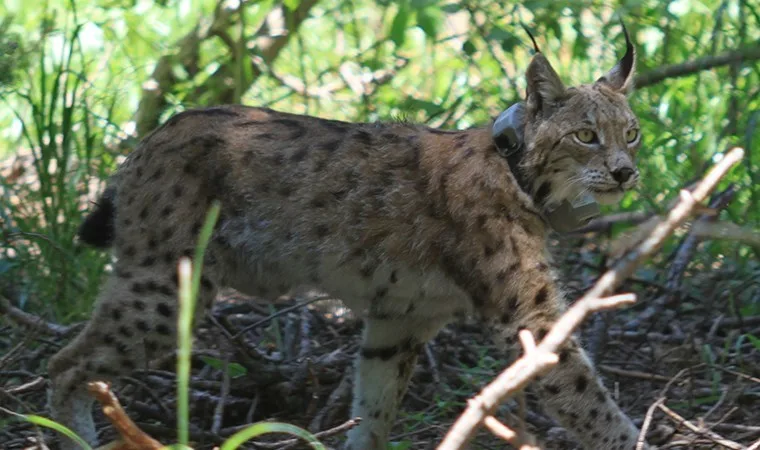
[491, 103, 599, 233]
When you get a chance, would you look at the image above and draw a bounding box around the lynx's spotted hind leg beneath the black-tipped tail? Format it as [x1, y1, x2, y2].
[48, 264, 215, 450]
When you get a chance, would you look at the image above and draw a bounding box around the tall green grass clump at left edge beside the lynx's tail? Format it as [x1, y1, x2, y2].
[0, 10, 115, 322]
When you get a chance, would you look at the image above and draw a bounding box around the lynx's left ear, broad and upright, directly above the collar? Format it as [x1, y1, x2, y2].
[525, 53, 567, 116]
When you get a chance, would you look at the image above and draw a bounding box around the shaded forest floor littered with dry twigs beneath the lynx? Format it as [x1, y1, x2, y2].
[0, 238, 760, 450]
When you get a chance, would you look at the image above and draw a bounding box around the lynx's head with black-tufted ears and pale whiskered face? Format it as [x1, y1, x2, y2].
[520, 27, 641, 206]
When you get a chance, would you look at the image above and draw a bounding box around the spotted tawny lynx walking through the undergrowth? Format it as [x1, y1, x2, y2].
[49, 26, 641, 450]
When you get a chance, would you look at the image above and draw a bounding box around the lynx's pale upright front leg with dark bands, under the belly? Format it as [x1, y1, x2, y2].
[345, 317, 443, 450]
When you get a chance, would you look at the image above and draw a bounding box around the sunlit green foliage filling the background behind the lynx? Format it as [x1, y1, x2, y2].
[0, 0, 760, 320]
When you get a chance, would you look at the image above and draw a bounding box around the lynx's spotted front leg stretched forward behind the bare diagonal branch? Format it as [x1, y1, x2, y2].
[448, 215, 639, 450]
